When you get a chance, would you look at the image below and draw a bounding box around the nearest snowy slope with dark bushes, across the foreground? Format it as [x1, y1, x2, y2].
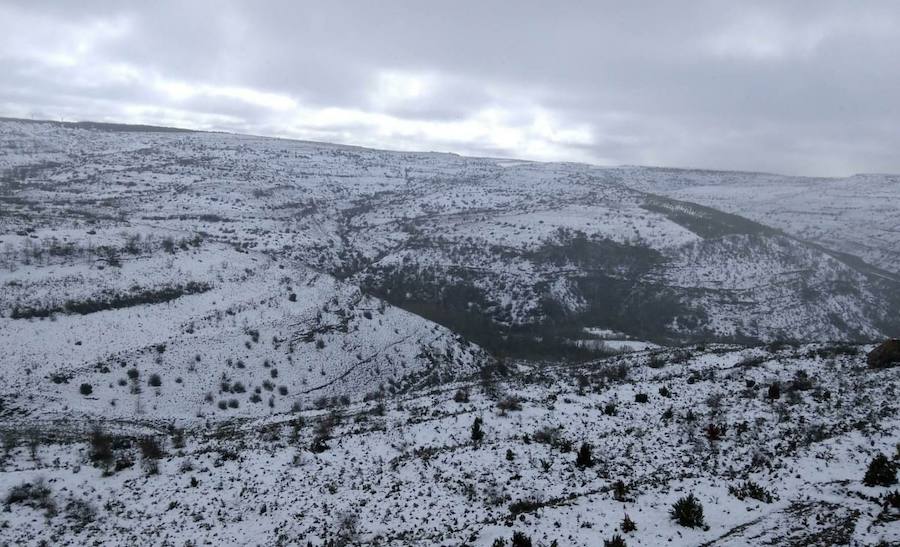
[0, 346, 900, 547]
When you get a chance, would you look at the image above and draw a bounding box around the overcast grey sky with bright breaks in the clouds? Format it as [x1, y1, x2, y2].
[0, 0, 900, 176]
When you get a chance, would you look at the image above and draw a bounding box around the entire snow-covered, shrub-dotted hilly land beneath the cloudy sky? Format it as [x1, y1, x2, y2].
[0, 120, 900, 547]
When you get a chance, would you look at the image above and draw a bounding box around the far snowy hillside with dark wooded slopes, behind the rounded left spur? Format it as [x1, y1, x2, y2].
[0, 121, 900, 355]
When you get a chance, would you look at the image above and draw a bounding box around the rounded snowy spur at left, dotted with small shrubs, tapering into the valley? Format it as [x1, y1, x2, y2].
[0, 234, 486, 420]
